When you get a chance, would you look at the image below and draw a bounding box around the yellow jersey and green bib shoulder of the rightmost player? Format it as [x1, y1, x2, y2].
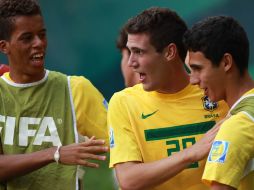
[203, 89, 254, 190]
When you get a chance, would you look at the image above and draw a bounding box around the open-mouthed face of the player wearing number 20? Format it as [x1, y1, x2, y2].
[127, 34, 169, 92]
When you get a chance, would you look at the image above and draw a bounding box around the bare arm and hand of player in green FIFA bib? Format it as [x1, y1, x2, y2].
[0, 139, 108, 181]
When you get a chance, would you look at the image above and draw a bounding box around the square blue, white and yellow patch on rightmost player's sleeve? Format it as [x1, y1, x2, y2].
[208, 141, 229, 163]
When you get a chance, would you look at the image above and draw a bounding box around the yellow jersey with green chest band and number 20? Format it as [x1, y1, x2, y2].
[108, 84, 228, 190]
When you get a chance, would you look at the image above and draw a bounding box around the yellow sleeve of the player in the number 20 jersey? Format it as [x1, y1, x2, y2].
[108, 93, 142, 167]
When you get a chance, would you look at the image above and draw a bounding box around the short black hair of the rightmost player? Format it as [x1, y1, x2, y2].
[183, 16, 249, 74]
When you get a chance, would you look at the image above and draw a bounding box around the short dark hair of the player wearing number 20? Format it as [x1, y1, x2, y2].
[126, 7, 187, 60]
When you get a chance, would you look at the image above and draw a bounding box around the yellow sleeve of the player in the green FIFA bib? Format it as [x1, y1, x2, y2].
[70, 76, 108, 144]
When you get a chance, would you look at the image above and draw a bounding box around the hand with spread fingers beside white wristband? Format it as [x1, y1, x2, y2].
[56, 137, 109, 168]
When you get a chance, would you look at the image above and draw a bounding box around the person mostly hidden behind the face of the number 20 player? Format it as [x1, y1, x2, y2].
[116, 26, 139, 87]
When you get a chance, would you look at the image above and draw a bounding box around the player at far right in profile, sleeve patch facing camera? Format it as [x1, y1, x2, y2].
[184, 16, 254, 190]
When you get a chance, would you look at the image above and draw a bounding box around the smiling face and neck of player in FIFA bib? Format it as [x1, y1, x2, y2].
[0, 15, 47, 83]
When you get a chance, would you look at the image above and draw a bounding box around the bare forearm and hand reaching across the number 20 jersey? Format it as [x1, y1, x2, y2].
[115, 122, 219, 190]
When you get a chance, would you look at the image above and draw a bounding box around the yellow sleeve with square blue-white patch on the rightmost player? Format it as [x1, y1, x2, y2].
[202, 112, 254, 188]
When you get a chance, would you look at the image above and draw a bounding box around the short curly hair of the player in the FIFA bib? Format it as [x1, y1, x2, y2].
[0, 0, 41, 40]
